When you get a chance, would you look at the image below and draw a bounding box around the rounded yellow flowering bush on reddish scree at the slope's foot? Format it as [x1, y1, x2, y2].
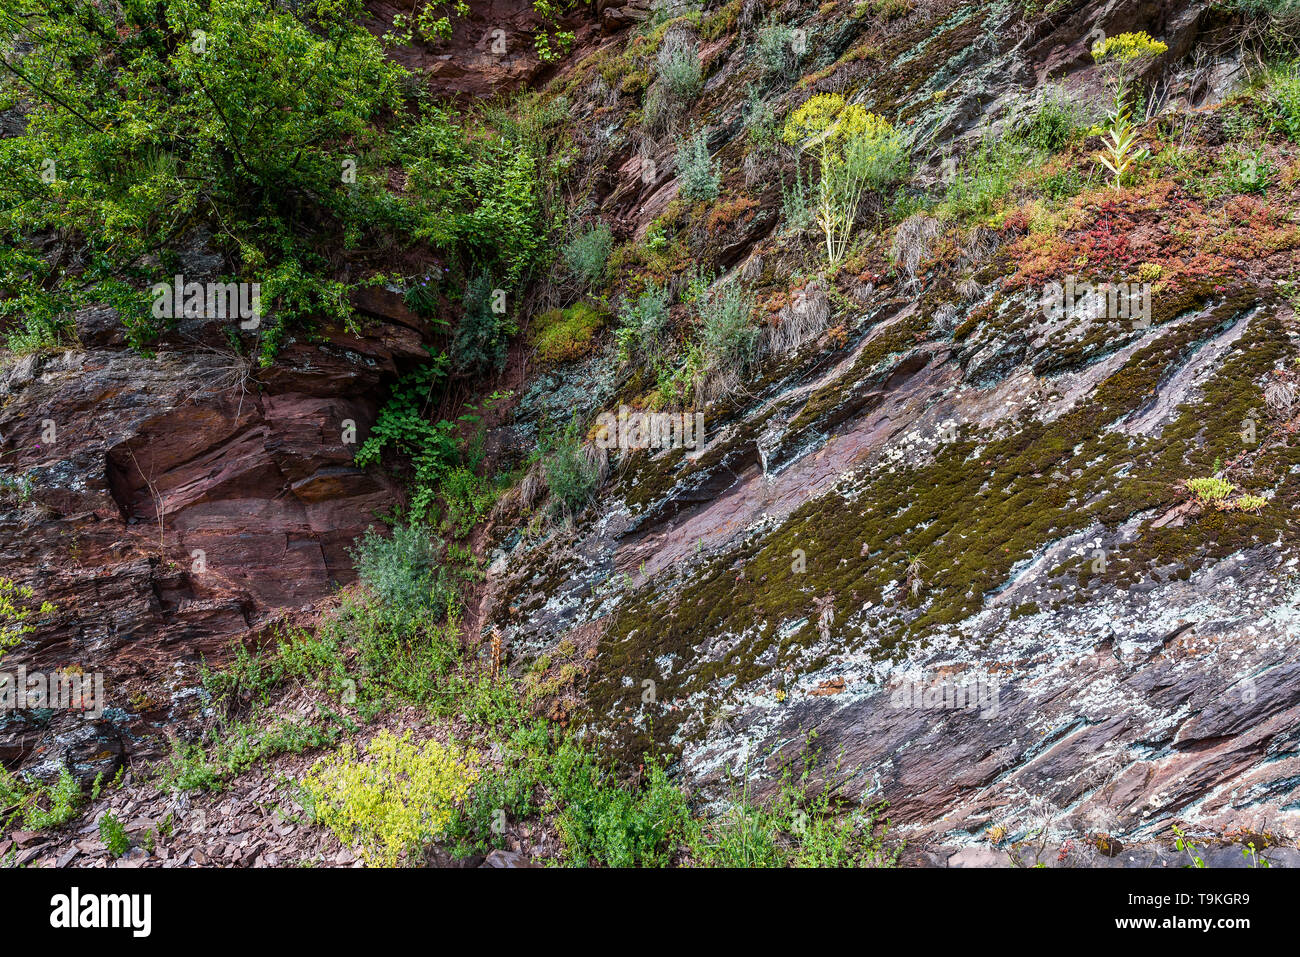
[303, 731, 480, 867]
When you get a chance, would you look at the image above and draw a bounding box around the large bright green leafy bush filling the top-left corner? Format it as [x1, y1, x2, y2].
[0, 0, 403, 345]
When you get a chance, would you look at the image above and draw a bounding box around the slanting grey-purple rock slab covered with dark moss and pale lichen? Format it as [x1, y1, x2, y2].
[485, 3, 1300, 862]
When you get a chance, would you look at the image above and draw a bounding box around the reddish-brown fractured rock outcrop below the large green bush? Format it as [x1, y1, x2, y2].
[0, 295, 426, 776]
